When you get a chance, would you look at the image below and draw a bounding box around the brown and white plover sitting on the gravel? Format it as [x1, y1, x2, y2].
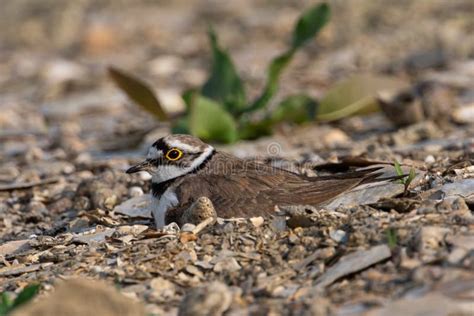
[126, 134, 388, 228]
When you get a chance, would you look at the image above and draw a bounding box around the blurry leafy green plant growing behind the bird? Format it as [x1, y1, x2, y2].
[109, 3, 330, 143]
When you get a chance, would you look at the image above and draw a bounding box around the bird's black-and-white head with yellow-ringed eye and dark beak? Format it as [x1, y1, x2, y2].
[126, 134, 214, 183]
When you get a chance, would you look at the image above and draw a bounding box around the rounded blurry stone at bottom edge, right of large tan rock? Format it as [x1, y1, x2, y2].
[178, 281, 232, 316]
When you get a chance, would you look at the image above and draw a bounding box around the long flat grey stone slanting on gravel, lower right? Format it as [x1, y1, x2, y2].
[314, 245, 392, 292]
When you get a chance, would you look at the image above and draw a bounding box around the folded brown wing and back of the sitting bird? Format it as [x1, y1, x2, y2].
[166, 157, 378, 223]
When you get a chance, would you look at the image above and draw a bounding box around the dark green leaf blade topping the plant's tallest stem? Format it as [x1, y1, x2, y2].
[292, 3, 331, 49]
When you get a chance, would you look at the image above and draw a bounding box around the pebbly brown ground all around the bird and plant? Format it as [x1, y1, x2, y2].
[0, 0, 474, 315]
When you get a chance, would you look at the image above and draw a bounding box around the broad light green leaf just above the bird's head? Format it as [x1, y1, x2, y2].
[188, 95, 238, 143]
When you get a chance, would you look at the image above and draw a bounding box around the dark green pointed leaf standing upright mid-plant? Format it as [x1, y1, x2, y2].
[201, 28, 247, 113]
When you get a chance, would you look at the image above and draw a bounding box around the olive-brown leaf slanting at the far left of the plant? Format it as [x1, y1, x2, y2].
[108, 67, 168, 121]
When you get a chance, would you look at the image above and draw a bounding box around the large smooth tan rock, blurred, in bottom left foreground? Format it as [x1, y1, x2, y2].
[12, 279, 145, 316]
